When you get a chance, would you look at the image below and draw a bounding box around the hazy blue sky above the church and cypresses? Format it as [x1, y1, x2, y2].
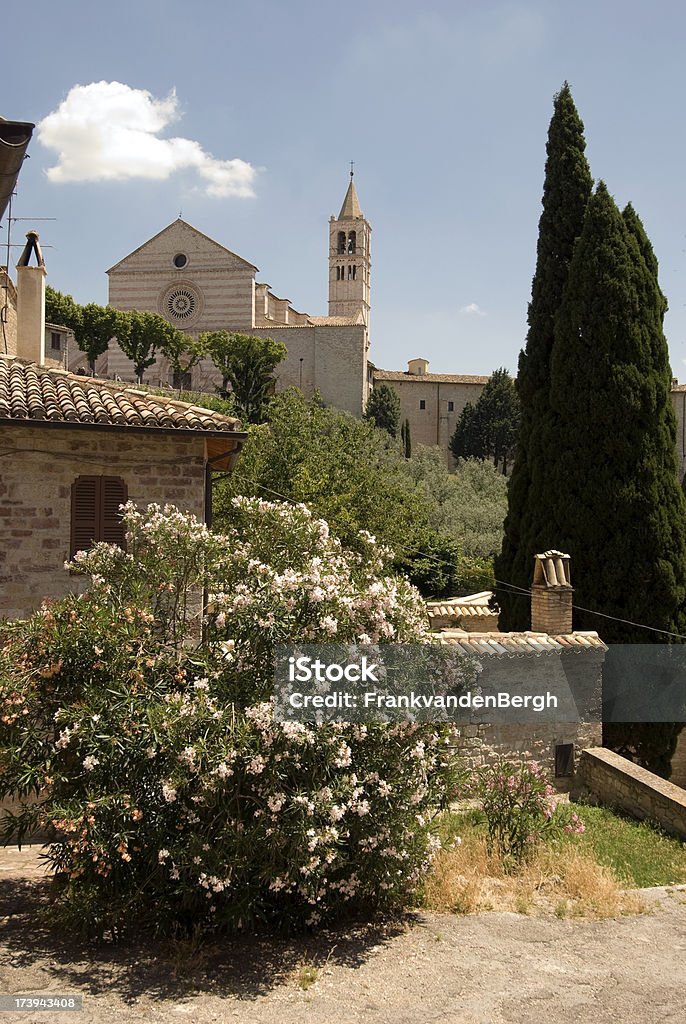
[0, 0, 686, 380]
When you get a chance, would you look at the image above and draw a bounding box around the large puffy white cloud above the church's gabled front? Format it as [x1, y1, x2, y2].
[38, 82, 256, 199]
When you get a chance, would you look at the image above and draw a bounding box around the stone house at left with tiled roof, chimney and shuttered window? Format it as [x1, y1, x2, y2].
[0, 239, 246, 618]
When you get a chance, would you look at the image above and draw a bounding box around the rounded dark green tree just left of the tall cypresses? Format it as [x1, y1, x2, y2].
[449, 368, 519, 474]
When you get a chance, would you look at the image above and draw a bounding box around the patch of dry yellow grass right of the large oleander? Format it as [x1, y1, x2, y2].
[425, 834, 645, 918]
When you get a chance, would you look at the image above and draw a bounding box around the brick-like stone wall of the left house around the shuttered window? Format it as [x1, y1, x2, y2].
[0, 425, 205, 618]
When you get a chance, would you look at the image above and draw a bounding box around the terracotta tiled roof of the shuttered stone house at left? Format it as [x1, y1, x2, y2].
[0, 356, 241, 434]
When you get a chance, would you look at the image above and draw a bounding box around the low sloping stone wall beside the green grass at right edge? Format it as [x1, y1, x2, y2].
[578, 746, 686, 839]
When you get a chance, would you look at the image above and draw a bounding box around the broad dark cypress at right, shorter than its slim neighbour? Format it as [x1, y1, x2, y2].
[544, 183, 686, 774]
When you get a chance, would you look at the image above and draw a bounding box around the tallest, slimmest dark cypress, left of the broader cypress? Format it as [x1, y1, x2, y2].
[496, 82, 592, 630]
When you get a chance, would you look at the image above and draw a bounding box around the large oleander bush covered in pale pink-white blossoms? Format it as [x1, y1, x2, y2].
[0, 498, 461, 935]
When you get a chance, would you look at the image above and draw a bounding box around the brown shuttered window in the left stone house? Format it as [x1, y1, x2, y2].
[70, 476, 128, 558]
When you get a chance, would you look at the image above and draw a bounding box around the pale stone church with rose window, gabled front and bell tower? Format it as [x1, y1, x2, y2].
[102, 175, 372, 416]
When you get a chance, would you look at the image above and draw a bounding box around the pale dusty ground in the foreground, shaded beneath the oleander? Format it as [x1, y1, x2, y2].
[0, 847, 686, 1024]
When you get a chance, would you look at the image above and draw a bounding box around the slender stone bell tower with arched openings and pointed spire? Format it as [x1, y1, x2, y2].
[329, 164, 372, 327]
